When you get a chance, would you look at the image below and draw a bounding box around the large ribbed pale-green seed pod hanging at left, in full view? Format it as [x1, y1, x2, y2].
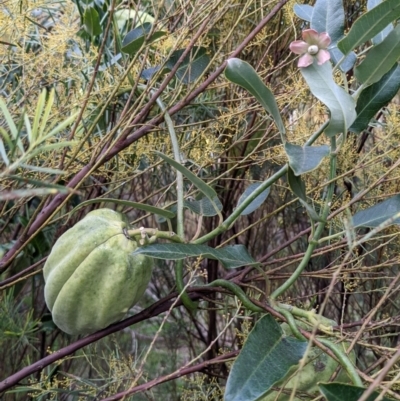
[43, 209, 153, 334]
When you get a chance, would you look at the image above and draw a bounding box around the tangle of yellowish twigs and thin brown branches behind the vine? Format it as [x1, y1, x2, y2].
[0, 0, 400, 400]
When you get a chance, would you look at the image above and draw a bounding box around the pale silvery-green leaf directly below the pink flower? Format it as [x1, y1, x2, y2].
[300, 60, 357, 136]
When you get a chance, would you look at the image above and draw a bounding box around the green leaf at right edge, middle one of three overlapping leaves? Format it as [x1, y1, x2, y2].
[355, 25, 400, 85]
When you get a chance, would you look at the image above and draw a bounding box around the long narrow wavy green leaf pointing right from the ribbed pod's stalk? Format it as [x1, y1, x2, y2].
[133, 244, 258, 269]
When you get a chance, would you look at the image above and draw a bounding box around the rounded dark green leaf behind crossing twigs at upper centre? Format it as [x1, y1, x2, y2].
[165, 46, 210, 84]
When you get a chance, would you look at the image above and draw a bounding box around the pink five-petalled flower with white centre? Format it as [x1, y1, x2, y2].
[289, 29, 331, 67]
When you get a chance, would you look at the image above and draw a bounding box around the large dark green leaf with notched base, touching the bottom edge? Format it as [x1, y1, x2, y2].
[224, 315, 307, 401]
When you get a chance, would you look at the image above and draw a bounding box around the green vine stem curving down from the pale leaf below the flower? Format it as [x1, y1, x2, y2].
[270, 136, 337, 301]
